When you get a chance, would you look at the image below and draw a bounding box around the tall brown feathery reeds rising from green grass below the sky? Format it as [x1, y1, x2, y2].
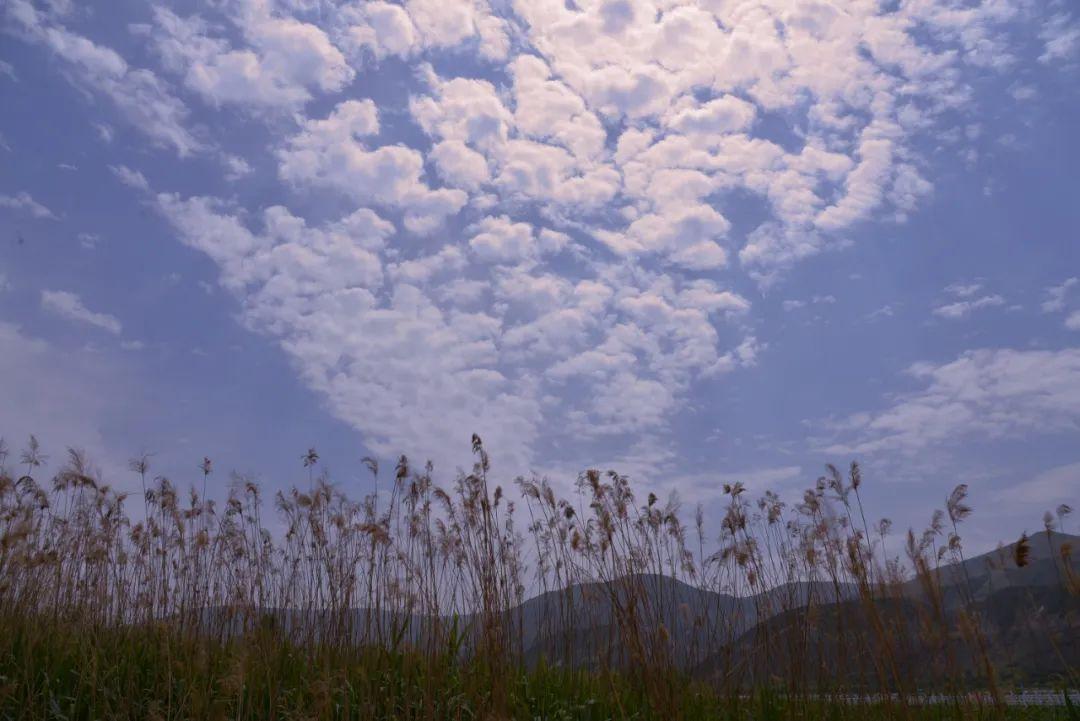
[0, 438, 1080, 721]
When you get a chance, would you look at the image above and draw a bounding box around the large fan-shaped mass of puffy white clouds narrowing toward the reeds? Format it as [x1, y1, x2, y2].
[12, 0, 1074, 468]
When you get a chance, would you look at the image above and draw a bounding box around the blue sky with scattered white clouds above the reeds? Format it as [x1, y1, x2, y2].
[0, 0, 1080, 547]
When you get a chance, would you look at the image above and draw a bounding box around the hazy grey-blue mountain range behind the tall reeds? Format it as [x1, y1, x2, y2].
[206, 532, 1080, 688]
